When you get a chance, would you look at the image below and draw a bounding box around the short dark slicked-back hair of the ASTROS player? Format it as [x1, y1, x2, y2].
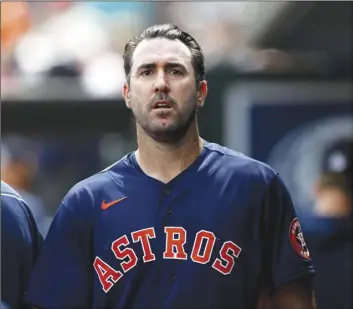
[123, 24, 205, 83]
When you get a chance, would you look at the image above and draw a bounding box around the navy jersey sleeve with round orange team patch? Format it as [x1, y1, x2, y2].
[262, 175, 315, 291]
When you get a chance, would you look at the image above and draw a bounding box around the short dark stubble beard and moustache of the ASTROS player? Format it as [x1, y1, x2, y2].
[132, 93, 197, 144]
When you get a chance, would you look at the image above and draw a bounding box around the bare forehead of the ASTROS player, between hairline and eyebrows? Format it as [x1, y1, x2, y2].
[132, 38, 191, 68]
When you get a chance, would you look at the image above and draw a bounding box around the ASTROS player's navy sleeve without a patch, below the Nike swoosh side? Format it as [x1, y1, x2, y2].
[26, 197, 93, 309]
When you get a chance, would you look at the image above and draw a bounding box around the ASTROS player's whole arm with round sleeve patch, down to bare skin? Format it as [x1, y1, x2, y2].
[258, 176, 316, 309]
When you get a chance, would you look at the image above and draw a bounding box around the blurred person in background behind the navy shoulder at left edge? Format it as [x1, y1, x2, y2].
[1, 135, 51, 237]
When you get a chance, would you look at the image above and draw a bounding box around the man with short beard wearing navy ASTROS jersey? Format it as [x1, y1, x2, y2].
[28, 25, 314, 309]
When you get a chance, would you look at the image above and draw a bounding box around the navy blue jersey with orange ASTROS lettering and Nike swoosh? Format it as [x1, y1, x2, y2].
[28, 142, 314, 309]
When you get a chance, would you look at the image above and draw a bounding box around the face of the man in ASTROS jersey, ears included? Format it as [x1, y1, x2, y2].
[123, 38, 207, 142]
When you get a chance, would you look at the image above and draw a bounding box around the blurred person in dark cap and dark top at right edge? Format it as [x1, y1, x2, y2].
[305, 139, 353, 309]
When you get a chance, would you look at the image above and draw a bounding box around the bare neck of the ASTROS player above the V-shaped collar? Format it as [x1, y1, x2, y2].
[136, 123, 202, 183]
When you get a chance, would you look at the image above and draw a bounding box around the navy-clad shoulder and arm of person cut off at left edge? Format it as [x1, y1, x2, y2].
[1, 181, 42, 308]
